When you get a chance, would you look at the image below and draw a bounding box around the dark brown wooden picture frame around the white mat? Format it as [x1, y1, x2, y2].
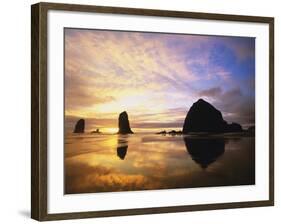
[31, 3, 274, 221]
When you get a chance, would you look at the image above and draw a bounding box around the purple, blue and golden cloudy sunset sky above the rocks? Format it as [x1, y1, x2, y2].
[64, 28, 255, 133]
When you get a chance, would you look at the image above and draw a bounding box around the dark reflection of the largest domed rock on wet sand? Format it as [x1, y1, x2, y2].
[184, 138, 225, 169]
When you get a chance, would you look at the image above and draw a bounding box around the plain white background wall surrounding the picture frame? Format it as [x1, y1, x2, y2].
[0, 0, 281, 224]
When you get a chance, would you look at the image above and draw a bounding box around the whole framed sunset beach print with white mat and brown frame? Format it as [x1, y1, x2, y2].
[31, 3, 274, 221]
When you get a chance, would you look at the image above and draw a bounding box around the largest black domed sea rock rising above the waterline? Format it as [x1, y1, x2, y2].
[182, 99, 242, 134]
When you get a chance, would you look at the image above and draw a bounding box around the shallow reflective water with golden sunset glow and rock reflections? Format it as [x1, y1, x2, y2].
[65, 134, 255, 194]
